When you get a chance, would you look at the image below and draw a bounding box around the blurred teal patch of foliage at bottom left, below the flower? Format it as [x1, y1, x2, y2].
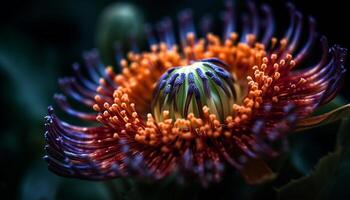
[19, 160, 112, 200]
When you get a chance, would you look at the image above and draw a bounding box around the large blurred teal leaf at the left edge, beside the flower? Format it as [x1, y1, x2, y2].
[0, 32, 58, 120]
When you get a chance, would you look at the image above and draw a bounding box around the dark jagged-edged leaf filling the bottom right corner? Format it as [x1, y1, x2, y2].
[277, 119, 350, 200]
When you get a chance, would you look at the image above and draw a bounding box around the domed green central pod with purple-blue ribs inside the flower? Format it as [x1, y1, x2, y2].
[152, 59, 237, 122]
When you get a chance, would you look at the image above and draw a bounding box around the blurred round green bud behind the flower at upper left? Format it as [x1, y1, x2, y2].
[96, 3, 144, 69]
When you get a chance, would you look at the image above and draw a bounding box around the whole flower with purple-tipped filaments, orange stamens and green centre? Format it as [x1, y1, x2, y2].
[44, 1, 348, 186]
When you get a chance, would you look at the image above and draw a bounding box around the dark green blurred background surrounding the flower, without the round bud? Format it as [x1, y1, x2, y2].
[0, 0, 350, 200]
